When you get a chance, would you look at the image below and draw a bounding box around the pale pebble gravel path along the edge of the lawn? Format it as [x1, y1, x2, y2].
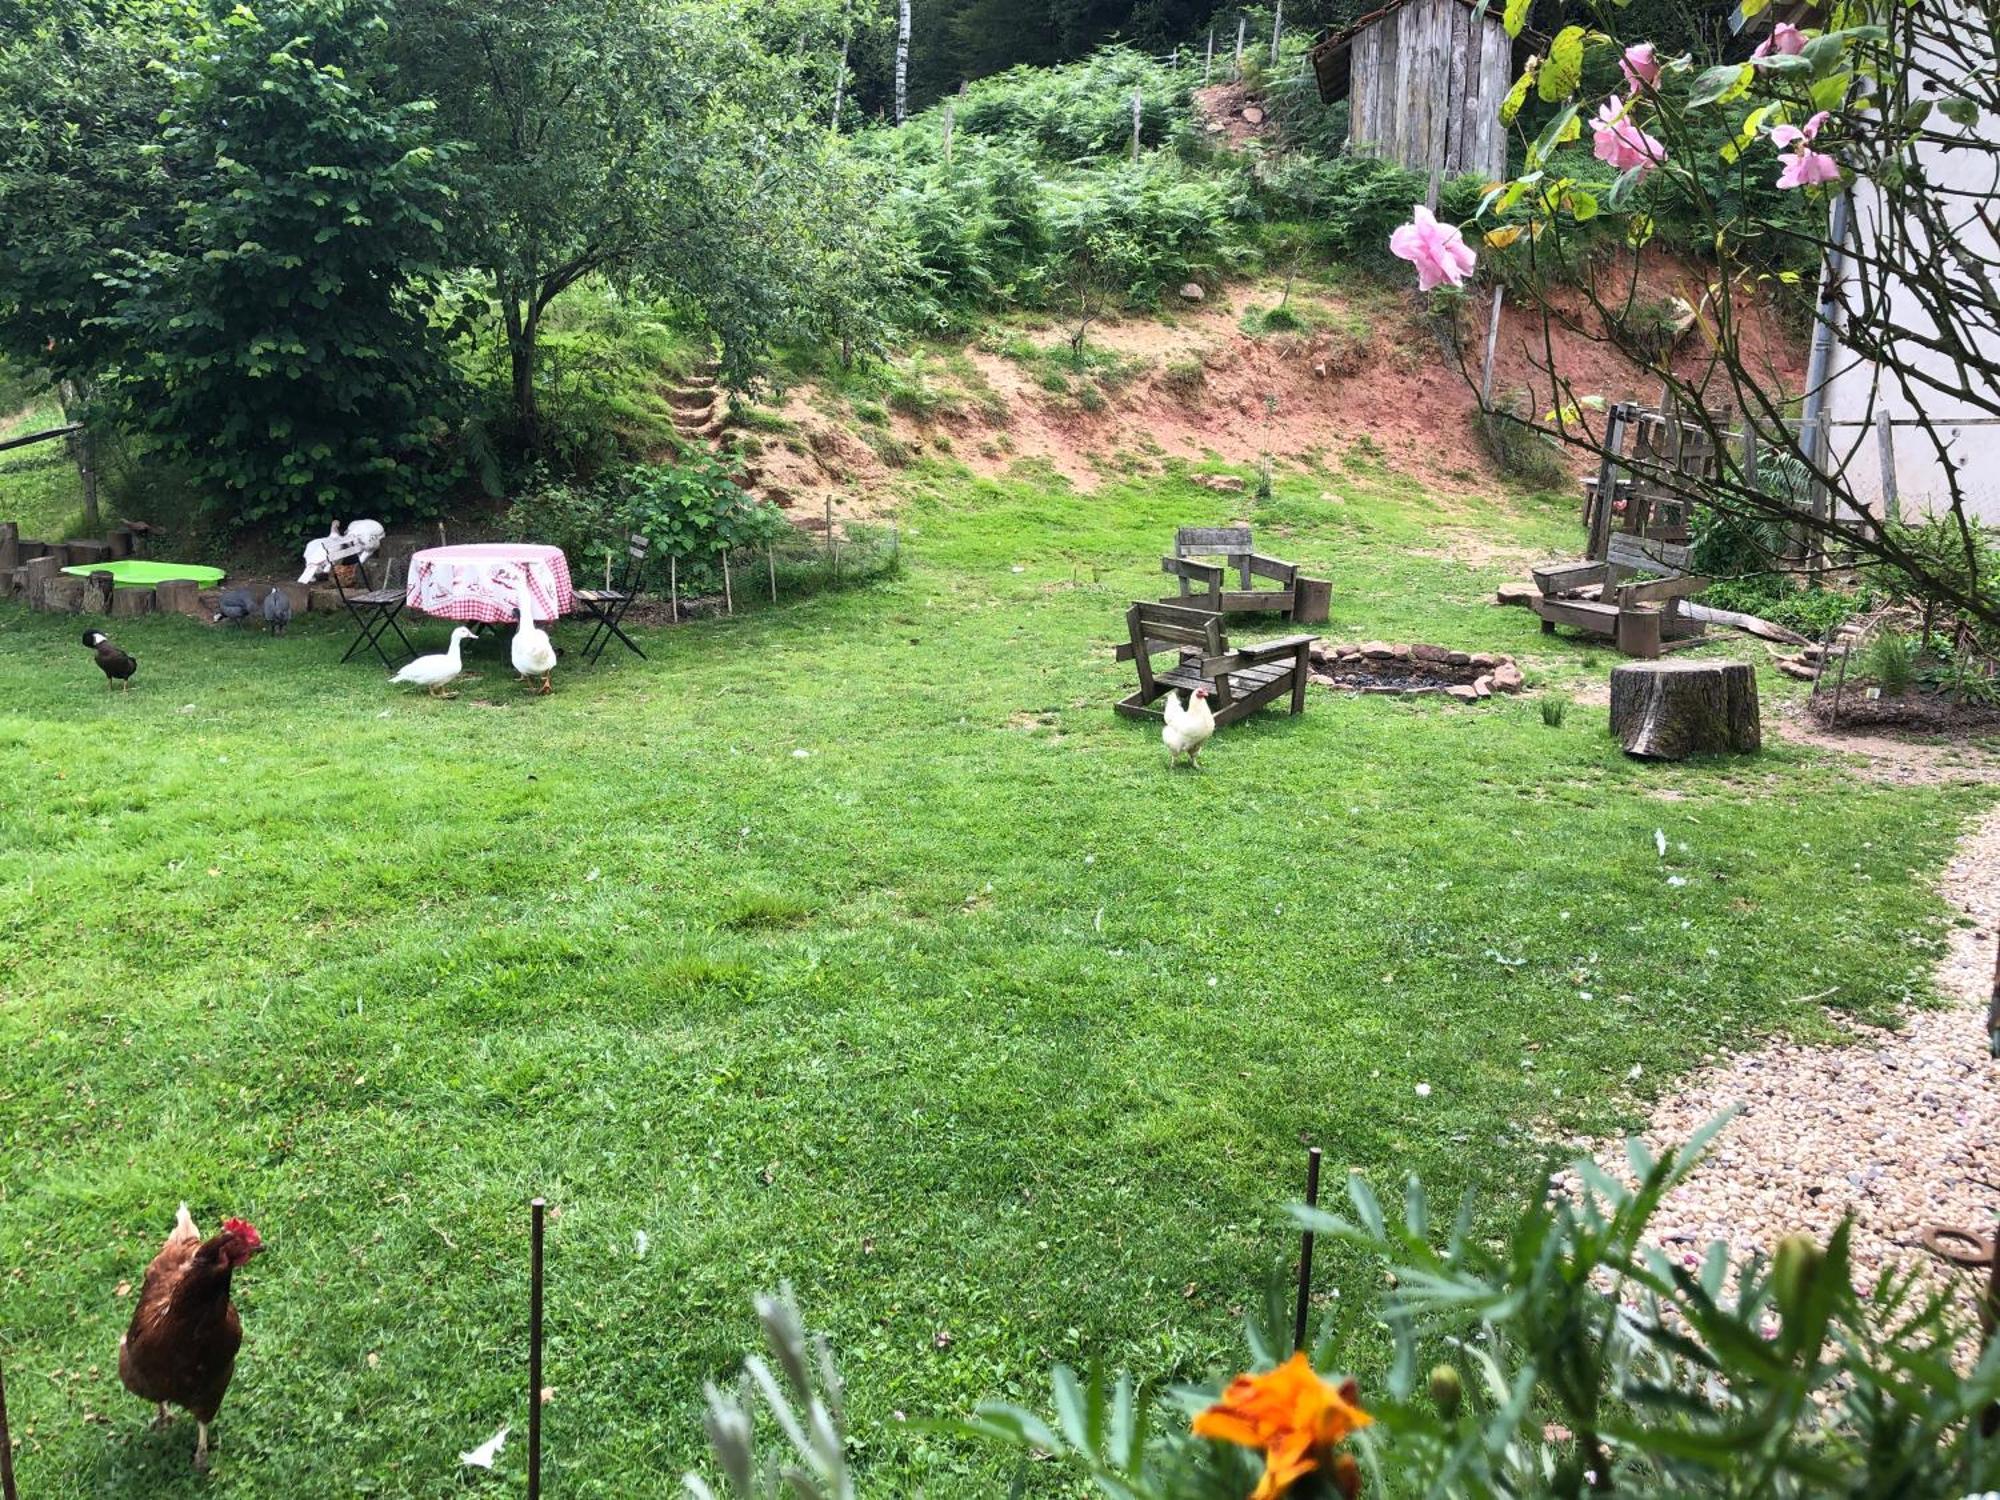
[1566, 810, 2000, 1292]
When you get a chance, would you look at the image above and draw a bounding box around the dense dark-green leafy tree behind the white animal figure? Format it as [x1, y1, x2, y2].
[88, 4, 450, 522]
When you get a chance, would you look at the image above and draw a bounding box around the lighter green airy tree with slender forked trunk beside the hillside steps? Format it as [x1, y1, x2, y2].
[396, 0, 856, 446]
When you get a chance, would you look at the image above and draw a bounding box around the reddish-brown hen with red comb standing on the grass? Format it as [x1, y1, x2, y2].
[118, 1204, 264, 1468]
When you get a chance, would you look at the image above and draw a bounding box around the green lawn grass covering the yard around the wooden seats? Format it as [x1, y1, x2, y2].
[0, 462, 1980, 1500]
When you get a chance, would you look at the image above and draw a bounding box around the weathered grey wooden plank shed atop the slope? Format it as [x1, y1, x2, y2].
[1312, 0, 1518, 178]
